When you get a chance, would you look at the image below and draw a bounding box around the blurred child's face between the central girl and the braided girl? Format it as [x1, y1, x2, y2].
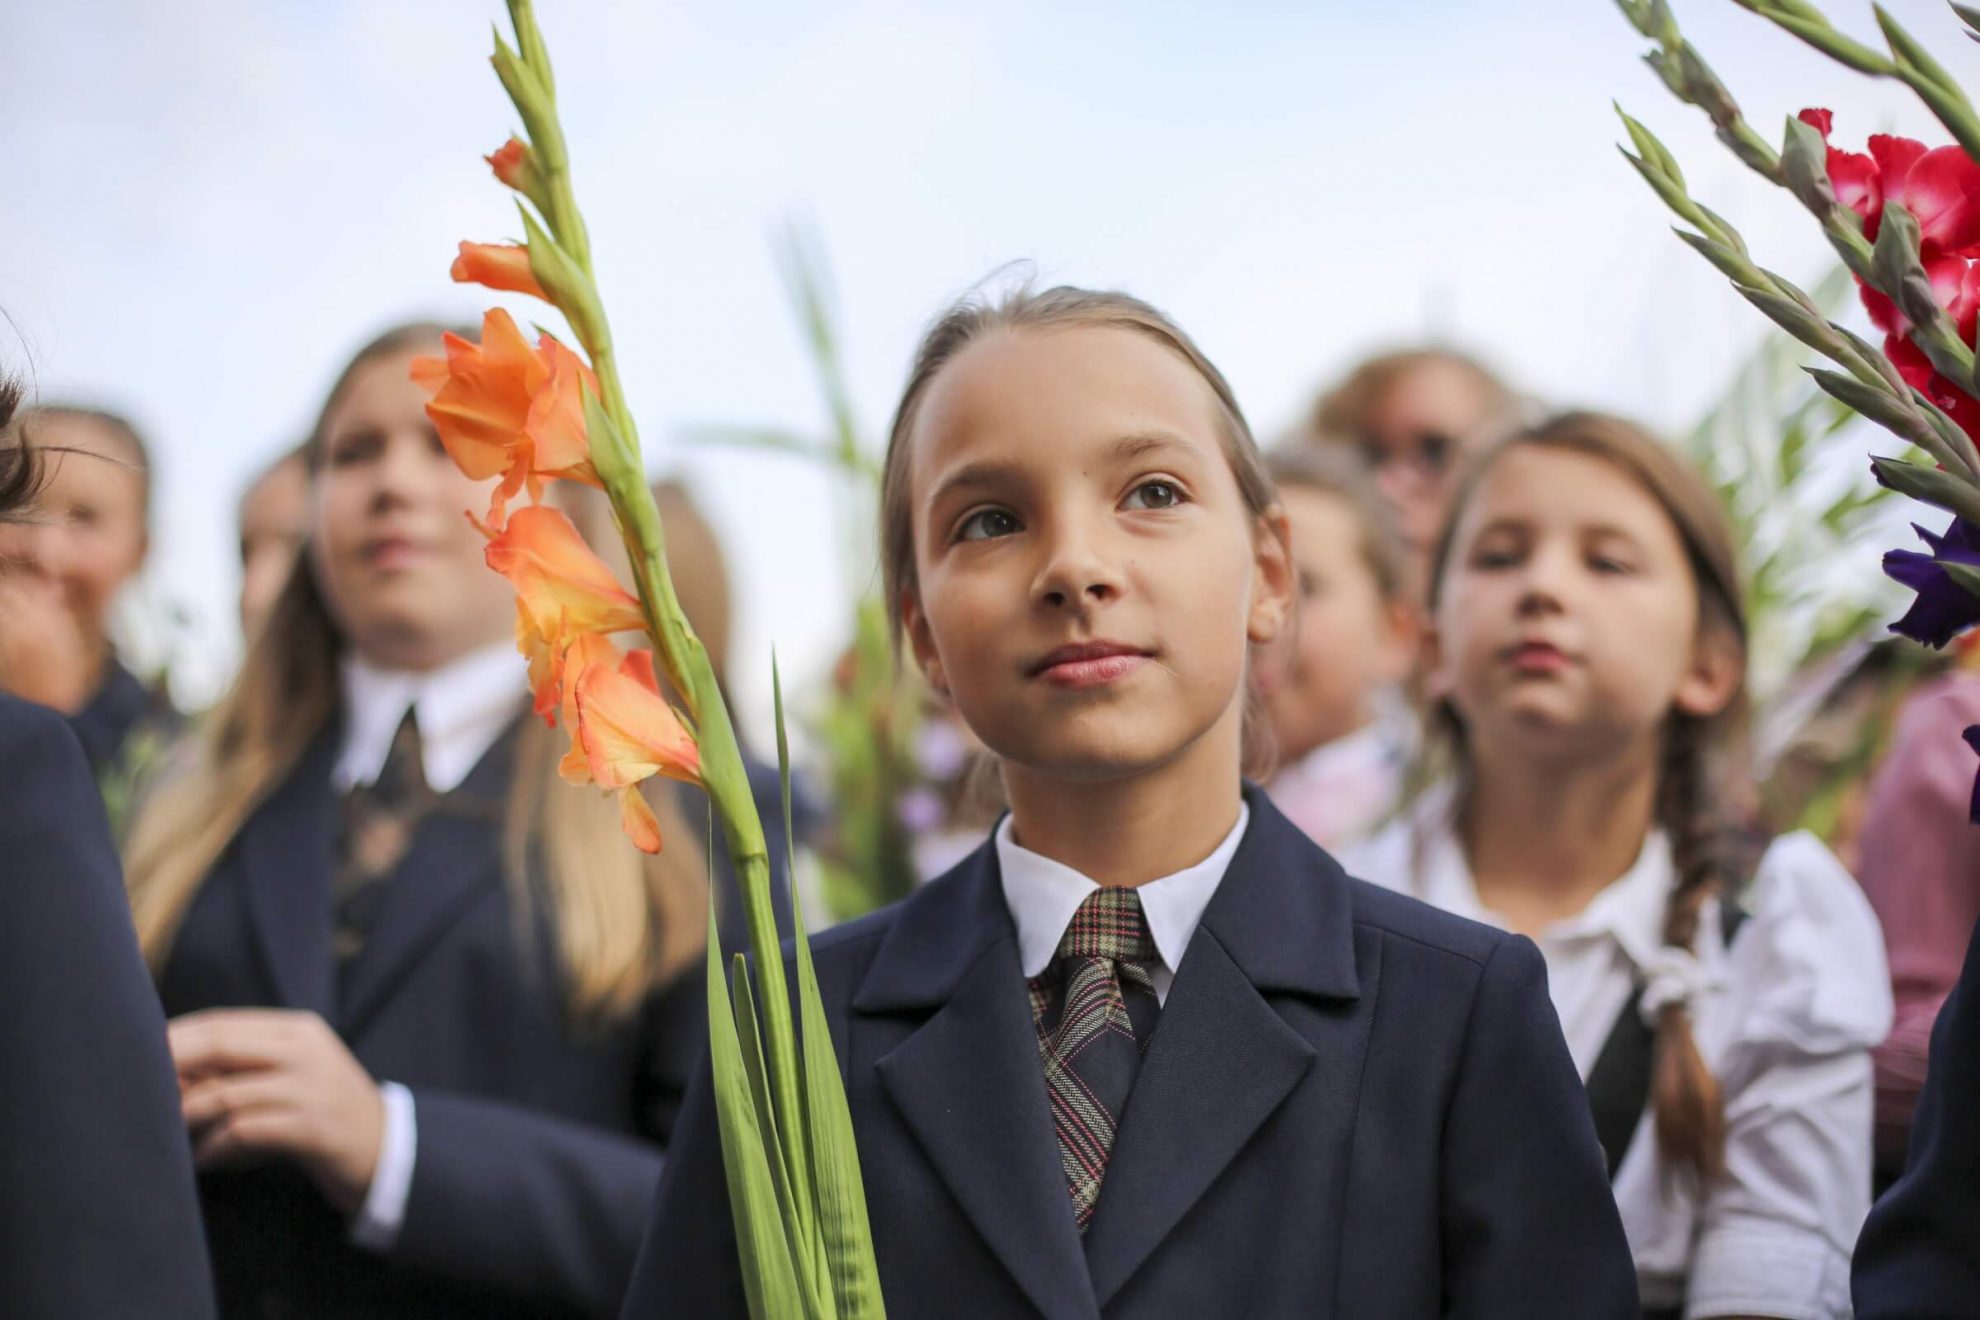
[1259, 487, 1416, 760]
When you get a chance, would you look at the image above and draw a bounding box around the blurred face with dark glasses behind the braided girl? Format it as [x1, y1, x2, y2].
[1360, 360, 1491, 558]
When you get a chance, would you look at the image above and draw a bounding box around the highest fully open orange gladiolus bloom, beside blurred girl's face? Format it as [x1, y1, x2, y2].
[412, 307, 598, 528]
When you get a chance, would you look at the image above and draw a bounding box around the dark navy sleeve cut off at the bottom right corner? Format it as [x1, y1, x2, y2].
[1849, 910, 1980, 1320]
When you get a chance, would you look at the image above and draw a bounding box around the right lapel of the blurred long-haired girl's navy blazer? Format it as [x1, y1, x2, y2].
[339, 724, 518, 1039]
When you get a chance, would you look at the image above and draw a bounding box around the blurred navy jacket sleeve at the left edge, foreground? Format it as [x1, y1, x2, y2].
[0, 697, 214, 1320]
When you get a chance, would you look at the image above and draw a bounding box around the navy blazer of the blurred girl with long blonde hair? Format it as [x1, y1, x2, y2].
[160, 726, 707, 1320]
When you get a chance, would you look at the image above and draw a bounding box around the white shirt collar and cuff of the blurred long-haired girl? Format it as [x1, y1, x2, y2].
[331, 643, 527, 1251]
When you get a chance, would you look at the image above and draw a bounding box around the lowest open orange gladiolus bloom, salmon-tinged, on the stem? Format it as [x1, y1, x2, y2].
[558, 633, 701, 853]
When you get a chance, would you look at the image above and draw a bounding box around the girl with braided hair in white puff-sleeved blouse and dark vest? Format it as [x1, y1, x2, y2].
[1346, 414, 1891, 1318]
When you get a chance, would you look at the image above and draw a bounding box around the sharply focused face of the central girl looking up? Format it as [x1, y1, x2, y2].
[903, 327, 1291, 782]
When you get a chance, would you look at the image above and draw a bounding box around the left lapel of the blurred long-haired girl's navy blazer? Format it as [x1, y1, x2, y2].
[240, 720, 337, 1019]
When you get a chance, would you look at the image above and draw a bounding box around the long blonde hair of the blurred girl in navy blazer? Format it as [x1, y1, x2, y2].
[127, 325, 709, 1021]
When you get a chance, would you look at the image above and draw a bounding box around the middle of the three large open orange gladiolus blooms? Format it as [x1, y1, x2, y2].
[487, 505, 645, 724]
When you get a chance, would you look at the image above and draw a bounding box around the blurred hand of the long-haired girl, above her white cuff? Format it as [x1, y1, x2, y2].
[166, 1009, 384, 1215]
